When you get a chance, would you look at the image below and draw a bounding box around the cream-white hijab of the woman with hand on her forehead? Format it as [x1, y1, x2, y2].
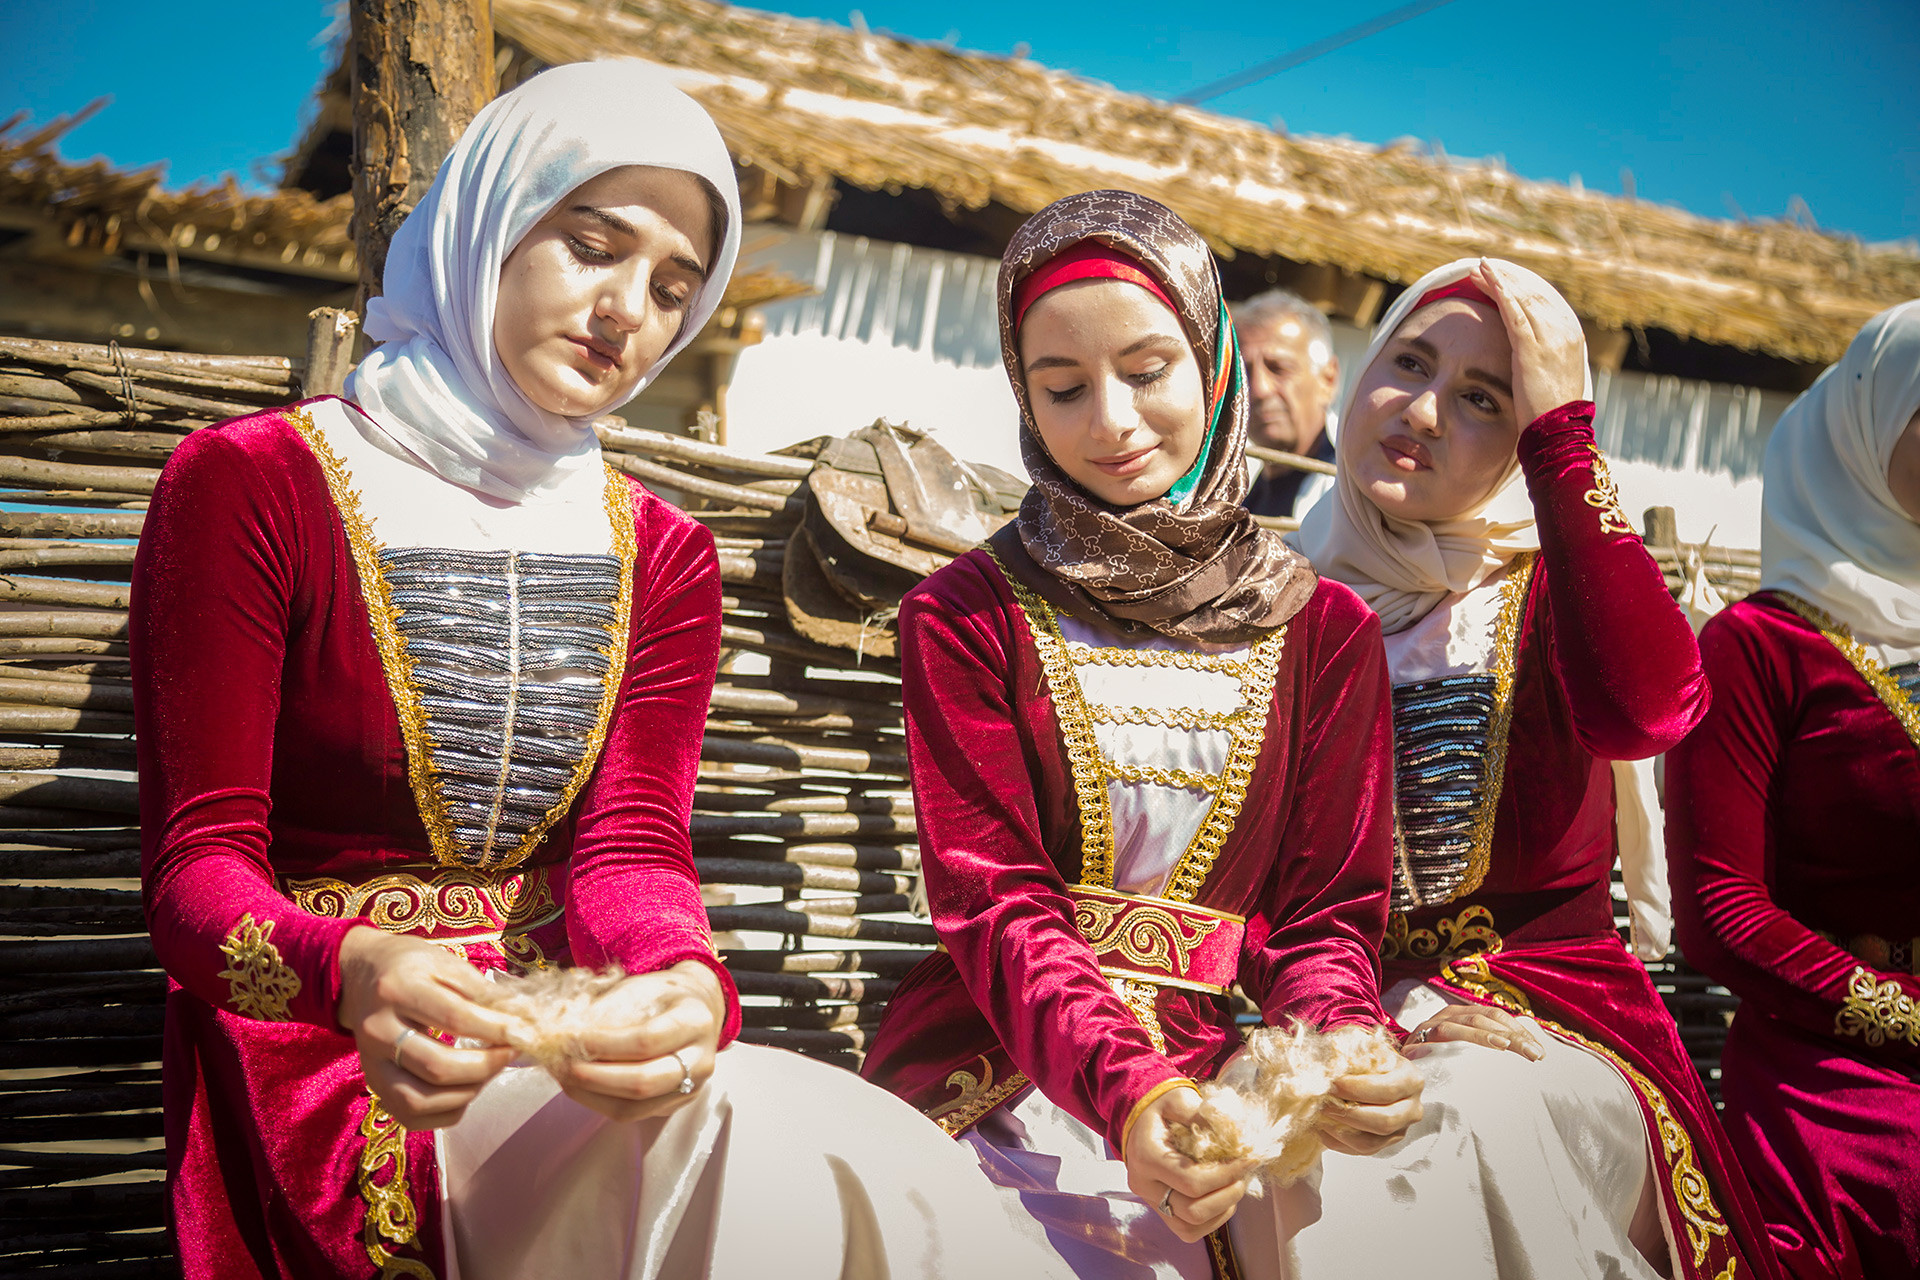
[1288, 257, 1594, 635]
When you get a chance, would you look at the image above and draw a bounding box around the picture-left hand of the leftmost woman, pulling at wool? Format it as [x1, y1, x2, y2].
[336, 925, 513, 1128]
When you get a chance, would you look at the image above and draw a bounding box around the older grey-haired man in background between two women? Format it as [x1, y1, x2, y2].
[1233, 290, 1340, 516]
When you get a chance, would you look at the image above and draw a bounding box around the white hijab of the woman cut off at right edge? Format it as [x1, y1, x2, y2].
[1761, 299, 1920, 647]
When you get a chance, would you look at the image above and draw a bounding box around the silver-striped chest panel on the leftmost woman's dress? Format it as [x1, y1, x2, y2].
[380, 547, 620, 867]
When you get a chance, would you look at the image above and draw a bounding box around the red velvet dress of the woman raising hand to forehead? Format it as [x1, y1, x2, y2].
[1384, 403, 1772, 1280]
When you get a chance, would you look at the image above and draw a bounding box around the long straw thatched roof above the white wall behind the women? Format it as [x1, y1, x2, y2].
[476, 0, 1920, 363]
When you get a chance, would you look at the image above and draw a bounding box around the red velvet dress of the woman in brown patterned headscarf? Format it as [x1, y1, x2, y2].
[864, 551, 1392, 1150]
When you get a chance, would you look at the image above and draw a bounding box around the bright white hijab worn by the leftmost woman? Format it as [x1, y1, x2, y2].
[348, 58, 741, 503]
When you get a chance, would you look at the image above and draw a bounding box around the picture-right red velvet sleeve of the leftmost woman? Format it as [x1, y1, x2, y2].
[566, 485, 739, 1044]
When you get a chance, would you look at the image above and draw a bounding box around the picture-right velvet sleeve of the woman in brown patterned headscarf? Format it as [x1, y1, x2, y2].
[1240, 580, 1394, 1027]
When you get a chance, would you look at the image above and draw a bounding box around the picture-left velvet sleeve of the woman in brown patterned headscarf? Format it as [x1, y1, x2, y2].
[900, 576, 1185, 1150]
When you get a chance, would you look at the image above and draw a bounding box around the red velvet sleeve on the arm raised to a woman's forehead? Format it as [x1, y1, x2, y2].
[1519, 401, 1711, 760]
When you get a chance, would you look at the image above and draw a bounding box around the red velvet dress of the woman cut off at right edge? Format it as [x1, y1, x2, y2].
[1667, 591, 1920, 1280]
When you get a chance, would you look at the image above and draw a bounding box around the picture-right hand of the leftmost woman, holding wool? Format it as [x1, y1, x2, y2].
[559, 960, 726, 1121]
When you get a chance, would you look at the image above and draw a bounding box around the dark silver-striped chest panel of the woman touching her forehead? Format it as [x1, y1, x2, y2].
[1392, 676, 1494, 912]
